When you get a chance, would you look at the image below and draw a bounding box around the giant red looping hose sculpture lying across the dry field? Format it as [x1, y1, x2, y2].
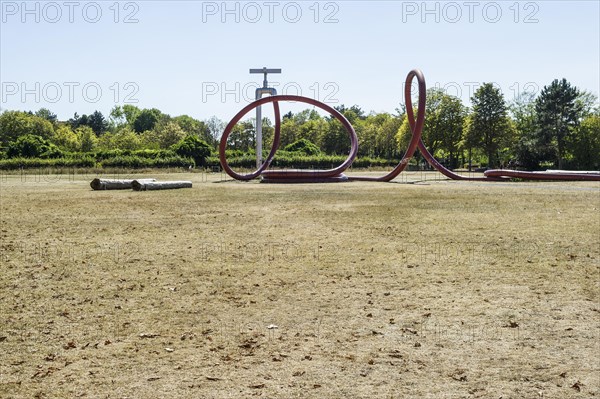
[219, 69, 600, 183]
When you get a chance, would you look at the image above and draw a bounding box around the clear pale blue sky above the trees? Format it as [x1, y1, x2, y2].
[0, 1, 600, 120]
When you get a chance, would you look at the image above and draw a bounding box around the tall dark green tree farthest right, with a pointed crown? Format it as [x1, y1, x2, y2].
[535, 78, 582, 169]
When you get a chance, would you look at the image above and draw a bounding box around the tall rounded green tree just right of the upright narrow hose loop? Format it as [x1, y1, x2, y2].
[467, 83, 512, 168]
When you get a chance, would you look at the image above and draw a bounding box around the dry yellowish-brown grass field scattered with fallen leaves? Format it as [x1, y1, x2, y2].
[0, 170, 600, 399]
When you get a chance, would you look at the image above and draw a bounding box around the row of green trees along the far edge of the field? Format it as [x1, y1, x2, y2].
[0, 79, 600, 170]
